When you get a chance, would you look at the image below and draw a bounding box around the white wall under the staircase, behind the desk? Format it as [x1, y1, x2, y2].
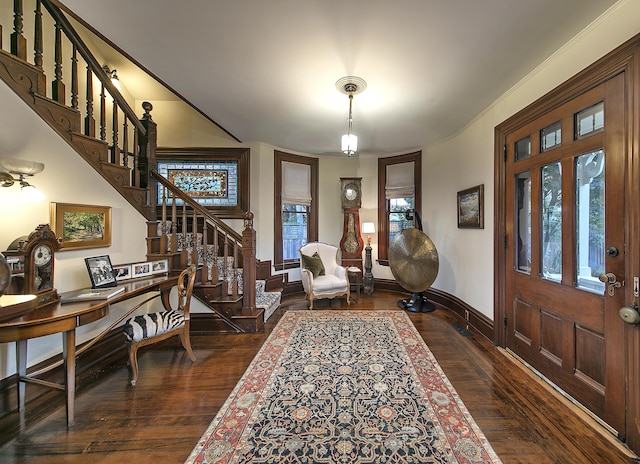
[0, 83, 158, 378]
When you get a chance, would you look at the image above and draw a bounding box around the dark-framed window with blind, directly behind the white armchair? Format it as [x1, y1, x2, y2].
[274, 151, 318, 270]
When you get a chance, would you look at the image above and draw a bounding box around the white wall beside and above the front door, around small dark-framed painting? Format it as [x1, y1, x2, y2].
[422, 0, 640, 319]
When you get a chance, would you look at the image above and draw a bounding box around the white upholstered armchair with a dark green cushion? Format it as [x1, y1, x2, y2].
[299, 242, 349, 309]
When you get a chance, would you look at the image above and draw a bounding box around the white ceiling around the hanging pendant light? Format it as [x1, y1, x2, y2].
[62, 0, 615, 155]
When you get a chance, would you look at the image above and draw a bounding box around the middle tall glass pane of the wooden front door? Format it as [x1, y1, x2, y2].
[540, 162, 562, 282]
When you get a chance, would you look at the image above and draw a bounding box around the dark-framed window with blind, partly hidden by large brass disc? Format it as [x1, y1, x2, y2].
[378, 152, 422, 266]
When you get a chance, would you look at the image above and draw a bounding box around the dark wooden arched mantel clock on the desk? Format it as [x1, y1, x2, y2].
[4, 224, 60, 307]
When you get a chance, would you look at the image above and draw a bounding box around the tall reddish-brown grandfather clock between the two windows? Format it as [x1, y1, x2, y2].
[340, 177, 364, 269]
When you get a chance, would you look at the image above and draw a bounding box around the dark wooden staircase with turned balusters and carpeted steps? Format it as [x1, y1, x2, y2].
[0, 0, 283, 332]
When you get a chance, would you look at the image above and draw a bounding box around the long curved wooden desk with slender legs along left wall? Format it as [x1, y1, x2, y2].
[0, 275, 178, 427]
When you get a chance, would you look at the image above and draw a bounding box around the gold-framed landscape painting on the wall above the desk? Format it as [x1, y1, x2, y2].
[50, 202, 111, 251]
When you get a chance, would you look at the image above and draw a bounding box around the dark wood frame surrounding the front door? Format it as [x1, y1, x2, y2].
[494, 35, 640, 453]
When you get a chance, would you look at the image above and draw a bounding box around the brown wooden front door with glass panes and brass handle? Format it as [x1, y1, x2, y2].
[505, 76, 632, 437]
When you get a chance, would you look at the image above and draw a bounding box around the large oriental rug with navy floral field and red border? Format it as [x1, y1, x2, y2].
[186, 310, 500, 464]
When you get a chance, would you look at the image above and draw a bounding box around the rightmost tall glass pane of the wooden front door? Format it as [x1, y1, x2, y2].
[575, 150, 605, 294]
